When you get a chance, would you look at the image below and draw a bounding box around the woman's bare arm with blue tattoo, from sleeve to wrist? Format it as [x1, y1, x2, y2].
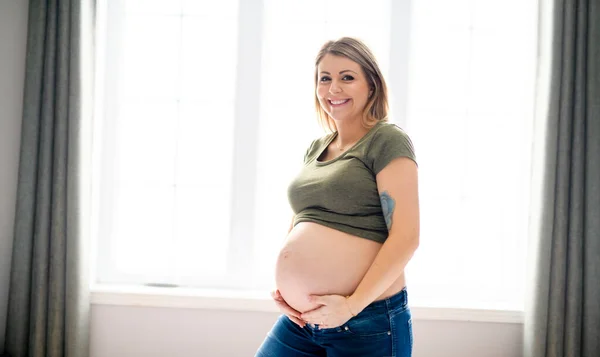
[347, 157, 420, 315]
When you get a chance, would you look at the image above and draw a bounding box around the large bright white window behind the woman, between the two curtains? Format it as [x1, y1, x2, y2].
[94, 0, 537, 309]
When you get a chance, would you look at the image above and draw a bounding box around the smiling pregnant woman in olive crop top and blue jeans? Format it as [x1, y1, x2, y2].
[256, 37, 419, 357]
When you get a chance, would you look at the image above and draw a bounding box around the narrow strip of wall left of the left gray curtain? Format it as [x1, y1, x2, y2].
[0, 0, 28, 354]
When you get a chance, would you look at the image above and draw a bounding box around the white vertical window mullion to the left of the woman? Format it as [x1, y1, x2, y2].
[226, 0, 263, 287]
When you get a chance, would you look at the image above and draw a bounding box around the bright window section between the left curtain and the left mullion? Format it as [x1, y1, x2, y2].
[98, 0, 238, 285]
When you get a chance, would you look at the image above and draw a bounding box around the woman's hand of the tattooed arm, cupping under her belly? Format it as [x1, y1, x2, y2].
[300, 295, 355, 328]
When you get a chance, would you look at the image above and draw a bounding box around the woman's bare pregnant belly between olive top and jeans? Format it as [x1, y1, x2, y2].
[275, 222, 404, 312]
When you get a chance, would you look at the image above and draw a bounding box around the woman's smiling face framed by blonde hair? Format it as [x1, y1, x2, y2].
[317, 54, 369, 121]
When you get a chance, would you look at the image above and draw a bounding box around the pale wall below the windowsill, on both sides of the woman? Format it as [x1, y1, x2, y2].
[91, 305, 523, 357]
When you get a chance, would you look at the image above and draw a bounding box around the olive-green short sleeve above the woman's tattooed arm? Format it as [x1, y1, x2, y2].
[367, 124, 417, 175]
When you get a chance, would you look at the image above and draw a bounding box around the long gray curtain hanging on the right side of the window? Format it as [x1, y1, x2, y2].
[524, 0, 600, 357]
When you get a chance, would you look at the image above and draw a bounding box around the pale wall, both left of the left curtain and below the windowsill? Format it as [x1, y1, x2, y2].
[0, 0, 522, 357]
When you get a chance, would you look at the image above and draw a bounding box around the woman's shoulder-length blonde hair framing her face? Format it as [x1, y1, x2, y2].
[315, 37, 389, 132]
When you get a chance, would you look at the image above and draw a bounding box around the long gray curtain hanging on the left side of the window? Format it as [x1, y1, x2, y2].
[5, 0, 94, 357]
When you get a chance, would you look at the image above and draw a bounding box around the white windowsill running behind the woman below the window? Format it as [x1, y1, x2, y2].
[91, 285, 523, 324]
